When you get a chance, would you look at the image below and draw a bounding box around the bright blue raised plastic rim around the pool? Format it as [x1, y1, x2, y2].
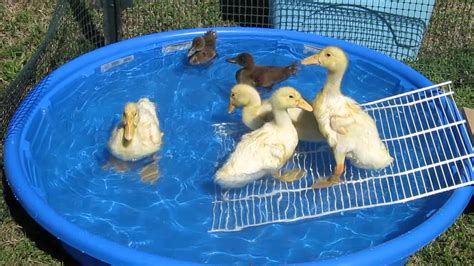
[3, 27, 474, 265]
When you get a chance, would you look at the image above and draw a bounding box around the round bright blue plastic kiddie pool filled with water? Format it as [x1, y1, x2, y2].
[4, 28, 472, 265]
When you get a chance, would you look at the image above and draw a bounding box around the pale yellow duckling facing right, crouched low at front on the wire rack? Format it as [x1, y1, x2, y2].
[215, 87, 313, 188]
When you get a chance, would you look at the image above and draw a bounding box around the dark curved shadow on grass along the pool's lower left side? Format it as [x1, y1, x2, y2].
[0, 170, 80, 265]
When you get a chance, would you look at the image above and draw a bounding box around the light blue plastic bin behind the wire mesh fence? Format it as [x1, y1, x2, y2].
[271, 0, 435, 59]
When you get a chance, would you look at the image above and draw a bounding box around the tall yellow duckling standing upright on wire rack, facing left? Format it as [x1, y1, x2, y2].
[301, 46, 393, 188]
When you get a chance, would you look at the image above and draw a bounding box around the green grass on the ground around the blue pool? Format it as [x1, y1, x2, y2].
[0, 0, 474, 265]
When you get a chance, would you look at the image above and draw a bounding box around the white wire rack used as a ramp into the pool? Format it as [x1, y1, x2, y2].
[210, 82, 474, 232]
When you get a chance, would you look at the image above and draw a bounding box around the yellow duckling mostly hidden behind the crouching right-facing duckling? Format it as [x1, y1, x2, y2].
[228, 84, 324, 141]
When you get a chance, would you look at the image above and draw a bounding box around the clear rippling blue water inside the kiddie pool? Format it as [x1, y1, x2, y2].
[28, 38, 448, 264]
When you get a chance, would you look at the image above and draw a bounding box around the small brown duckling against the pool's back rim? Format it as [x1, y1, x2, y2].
[188, 30, 217, 65]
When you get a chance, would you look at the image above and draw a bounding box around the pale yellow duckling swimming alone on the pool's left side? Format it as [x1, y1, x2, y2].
[108, 98, 163, 182]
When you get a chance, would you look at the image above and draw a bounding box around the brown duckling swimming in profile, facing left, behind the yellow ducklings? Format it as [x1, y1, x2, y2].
[227, 53, 298, 89]
